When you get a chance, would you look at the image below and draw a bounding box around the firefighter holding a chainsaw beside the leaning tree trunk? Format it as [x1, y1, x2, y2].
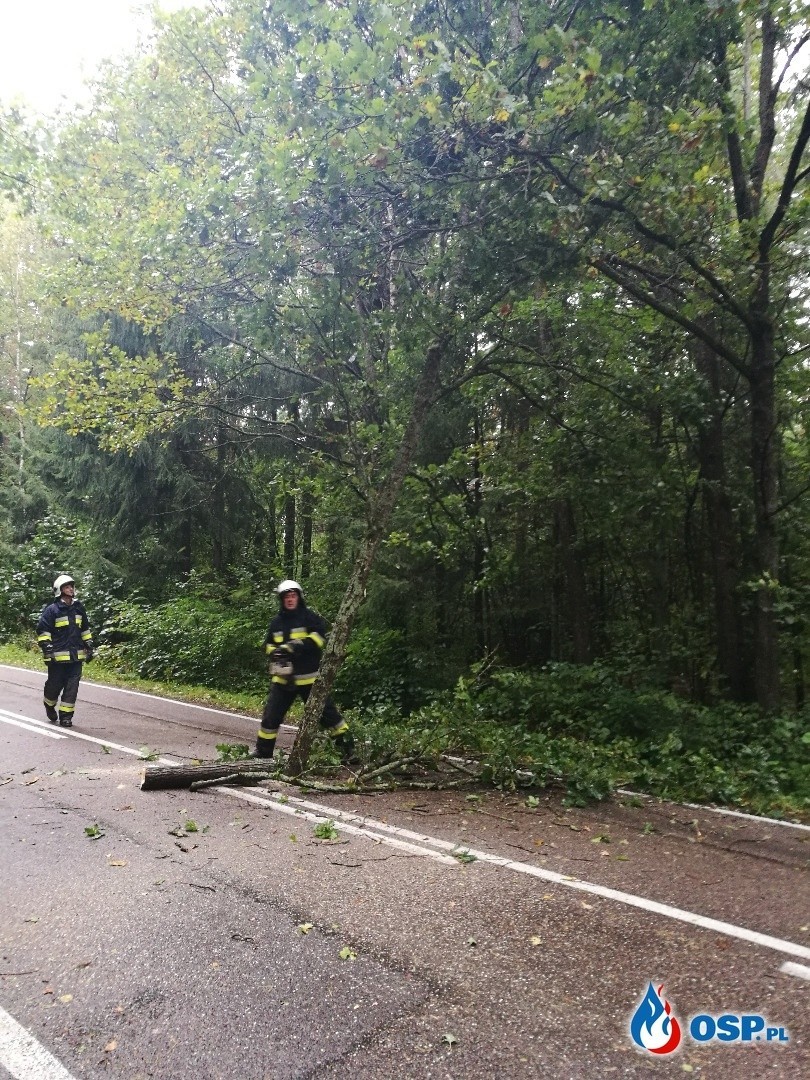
[256, 580, 354, 764]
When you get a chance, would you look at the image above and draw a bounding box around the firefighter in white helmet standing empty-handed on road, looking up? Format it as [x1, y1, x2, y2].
[37, 573, 93, 728]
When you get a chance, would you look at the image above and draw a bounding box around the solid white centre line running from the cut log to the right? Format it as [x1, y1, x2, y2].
[236, 787, 810, 960]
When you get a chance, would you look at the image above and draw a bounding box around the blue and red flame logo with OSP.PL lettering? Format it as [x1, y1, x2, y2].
[630, 983, 791, 1054]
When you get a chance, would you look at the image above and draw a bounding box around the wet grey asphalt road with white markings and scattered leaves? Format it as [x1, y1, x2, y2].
[0, 666, 810, 1080]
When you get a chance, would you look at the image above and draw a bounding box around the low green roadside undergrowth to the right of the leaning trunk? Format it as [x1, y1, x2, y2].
[366, 664, 810, 813]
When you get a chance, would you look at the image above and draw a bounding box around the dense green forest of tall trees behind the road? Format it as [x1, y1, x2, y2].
[0, 0, 810, 798]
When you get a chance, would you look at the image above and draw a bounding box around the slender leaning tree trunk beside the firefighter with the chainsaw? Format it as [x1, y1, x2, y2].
[287, 340, 445, 777]
